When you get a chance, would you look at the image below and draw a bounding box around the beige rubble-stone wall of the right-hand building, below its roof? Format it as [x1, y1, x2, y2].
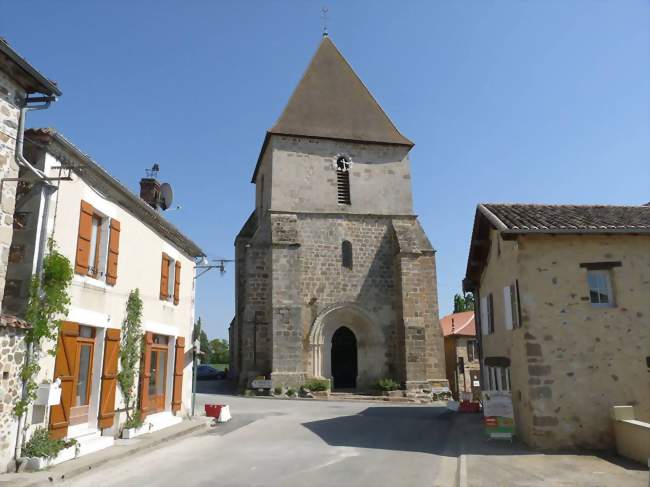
[480, 232, 650, 448]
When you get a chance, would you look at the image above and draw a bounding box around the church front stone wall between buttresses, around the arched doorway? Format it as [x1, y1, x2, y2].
[298, 215, 399, 384]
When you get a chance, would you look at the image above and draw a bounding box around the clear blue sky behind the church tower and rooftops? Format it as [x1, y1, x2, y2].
[0, 0, 650, 338]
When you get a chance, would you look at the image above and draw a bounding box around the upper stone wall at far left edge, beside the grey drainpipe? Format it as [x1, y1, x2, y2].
[0, 72, 25, 308]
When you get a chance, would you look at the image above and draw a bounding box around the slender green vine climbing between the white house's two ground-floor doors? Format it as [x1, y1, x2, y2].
[117, 289, 142, 424]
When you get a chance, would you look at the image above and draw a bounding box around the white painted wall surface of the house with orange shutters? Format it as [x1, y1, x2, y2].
[28, 154, 195, 436]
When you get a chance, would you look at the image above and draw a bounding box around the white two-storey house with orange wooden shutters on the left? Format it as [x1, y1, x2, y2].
[4, 129, 203, 466]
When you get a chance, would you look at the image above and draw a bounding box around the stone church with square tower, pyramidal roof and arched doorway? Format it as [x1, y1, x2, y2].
[230, 37, 447, 392]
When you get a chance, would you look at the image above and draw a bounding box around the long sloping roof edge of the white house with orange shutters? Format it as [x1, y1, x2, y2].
[25, 128, 205, 257]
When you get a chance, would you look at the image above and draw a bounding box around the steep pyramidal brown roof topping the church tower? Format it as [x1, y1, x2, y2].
[253, 37, 413, 182]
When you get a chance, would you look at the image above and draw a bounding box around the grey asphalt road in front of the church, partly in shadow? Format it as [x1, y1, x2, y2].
[60, 384, 456, 487]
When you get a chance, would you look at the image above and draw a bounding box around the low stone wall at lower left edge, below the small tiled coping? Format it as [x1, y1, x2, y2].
[0, 325, 26, 473]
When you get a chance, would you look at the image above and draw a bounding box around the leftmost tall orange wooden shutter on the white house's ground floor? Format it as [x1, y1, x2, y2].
[50, 321, 79, 439]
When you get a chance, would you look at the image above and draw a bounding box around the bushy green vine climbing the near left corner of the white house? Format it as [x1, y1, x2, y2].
[14, 239, 73, 417]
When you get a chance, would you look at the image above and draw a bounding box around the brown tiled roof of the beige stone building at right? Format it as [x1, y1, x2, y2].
[463, 203, 650, 291]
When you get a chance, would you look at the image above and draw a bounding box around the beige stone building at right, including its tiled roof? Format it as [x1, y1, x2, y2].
[463, 204, 650, 449]
